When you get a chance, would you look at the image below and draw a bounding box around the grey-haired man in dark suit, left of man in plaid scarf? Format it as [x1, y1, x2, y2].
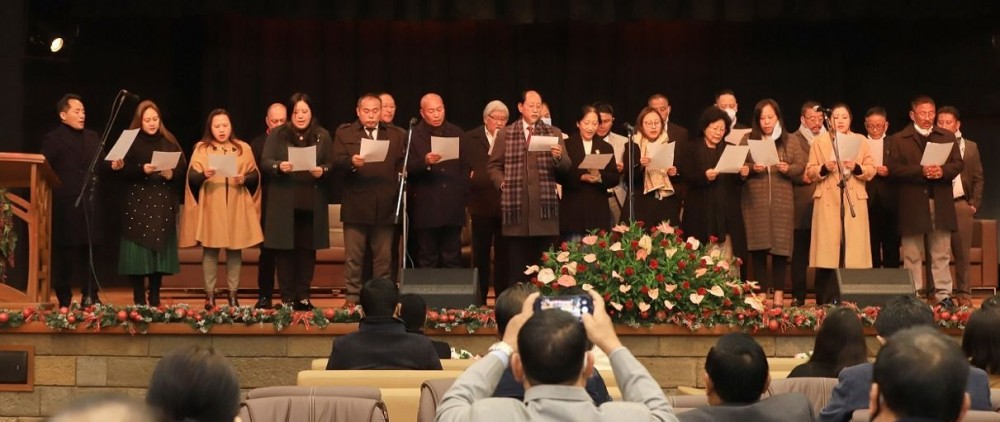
[461, 100, 510, 303]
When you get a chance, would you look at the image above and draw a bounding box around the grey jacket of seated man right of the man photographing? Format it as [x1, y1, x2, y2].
[677, 393, 816, 422]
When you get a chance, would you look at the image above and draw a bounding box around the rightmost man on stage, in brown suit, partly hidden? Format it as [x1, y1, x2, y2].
[937, 106, 983, 305]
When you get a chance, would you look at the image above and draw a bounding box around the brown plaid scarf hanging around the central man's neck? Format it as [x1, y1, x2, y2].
[500, 120, 566, 224]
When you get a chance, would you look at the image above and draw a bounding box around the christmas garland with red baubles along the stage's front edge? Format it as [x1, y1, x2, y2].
[0, 303, 975, 335]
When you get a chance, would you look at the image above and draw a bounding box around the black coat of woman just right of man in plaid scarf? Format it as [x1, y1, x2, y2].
[556, 134, 620, 233]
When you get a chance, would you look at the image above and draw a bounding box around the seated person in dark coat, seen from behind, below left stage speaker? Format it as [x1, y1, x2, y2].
[326, 277, 441, 369]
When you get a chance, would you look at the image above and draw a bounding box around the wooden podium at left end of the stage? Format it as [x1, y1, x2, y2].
[0, 152, 61, 308]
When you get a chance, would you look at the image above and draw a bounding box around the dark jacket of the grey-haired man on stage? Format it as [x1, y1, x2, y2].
[462, 126, 500, 218]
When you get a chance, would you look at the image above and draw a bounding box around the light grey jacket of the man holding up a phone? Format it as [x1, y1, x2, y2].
[435, 348, 677, 422]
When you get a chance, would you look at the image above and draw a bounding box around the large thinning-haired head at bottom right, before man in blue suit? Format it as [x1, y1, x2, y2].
[868, 327, 969, 422]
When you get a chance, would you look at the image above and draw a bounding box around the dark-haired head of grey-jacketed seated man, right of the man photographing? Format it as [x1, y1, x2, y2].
[705, 333, 771, 405]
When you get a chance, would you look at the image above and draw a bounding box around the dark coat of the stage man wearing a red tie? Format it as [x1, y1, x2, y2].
[333, 121, 406, 225]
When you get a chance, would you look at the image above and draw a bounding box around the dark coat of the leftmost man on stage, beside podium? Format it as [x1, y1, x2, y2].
[41, 124, 105, 246]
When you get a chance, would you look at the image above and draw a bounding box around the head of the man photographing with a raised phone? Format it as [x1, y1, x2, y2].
[512, 309, 594, 386]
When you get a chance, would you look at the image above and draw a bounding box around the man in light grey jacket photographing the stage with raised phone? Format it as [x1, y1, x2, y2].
[436, 289, 677, 422]
